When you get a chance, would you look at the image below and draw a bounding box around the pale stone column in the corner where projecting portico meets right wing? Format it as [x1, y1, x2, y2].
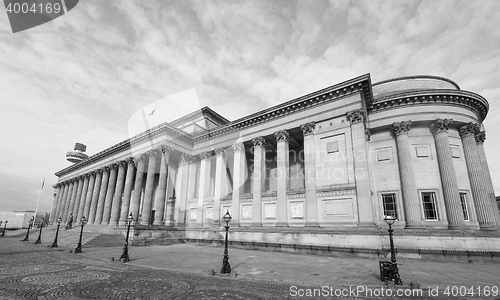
[174, 153, 192, 226]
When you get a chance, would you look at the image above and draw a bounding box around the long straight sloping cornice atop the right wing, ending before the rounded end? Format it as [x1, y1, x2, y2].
[193, 74, 373, 144]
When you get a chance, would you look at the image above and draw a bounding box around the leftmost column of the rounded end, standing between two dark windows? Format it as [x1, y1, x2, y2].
[392, 121, 422, 228]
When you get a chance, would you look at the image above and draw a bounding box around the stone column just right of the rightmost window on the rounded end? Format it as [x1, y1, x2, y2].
[460, 122, 496, 229]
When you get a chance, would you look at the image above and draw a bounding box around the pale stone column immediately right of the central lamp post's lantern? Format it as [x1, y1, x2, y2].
[231, 142, 247, 226]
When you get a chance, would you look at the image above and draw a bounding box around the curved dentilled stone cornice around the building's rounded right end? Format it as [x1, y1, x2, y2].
[368, 90, 489, 122]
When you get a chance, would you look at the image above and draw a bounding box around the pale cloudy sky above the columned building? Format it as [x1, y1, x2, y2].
[0, 0, 500, 211]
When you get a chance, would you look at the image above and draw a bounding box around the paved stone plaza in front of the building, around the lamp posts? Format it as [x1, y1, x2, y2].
[0, 230, 500, 300]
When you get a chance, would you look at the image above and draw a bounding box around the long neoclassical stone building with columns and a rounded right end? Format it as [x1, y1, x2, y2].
[52, 74, 500, 249]
